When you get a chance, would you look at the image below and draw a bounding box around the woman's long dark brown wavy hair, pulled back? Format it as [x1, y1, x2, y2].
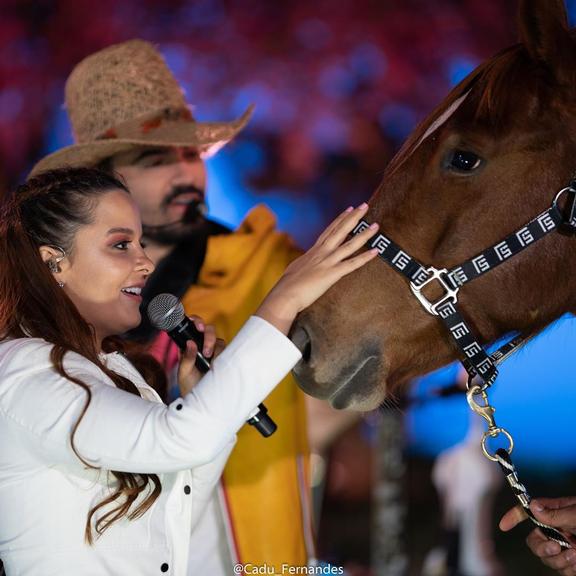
[0, 168, 164, 544]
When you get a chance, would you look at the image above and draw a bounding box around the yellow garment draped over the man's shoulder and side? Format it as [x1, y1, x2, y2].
[182, 206, 314, 569]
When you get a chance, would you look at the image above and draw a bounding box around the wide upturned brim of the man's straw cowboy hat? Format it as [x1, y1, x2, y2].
[28, 105, 254, 179]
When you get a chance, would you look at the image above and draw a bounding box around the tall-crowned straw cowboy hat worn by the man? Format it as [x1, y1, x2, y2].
[30, 40, 253, 177]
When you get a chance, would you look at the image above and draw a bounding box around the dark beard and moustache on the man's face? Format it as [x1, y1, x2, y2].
[142, 186, 209, 246]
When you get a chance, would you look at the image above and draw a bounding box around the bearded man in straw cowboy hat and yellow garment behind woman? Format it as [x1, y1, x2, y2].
[32, 40, 313, 576]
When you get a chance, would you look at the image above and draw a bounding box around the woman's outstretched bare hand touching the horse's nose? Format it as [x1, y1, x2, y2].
[256, 204, 378, 334]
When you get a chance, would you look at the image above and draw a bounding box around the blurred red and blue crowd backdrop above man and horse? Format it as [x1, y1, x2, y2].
[0, 0, 514, 245]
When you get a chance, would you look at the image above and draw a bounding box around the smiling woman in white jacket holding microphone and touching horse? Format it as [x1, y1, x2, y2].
[0, 168, 377, 576]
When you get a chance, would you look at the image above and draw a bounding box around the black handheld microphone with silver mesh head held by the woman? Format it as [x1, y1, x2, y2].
[147, 294, 277, 438]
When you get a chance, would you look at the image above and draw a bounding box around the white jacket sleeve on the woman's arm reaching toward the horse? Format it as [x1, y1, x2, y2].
[0, 317, 300, 473]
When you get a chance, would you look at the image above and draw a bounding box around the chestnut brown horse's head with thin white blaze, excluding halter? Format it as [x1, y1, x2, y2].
[293, 0, 576, 409]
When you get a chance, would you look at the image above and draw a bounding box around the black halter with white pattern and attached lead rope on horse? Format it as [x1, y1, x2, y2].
[352, 181, 576, 548]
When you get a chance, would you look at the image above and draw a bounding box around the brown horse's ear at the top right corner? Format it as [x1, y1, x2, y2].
[518, 0, 576, 83]
